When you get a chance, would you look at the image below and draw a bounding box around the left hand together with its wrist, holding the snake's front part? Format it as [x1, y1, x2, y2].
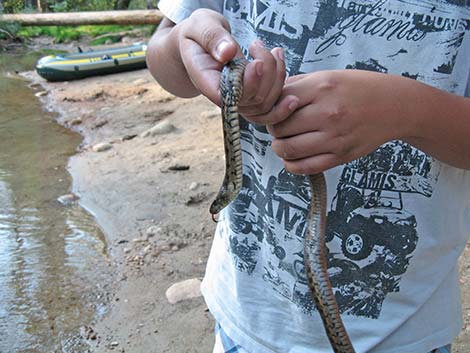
[148, 9, 290, 124]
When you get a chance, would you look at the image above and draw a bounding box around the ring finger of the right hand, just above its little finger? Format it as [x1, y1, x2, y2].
[272, 131, 332, 160]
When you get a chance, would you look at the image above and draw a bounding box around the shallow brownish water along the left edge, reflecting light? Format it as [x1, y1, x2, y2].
[0, 48, 109, 353]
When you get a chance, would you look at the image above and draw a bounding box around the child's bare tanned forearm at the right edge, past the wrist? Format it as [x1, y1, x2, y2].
[397, 81, 470, 169]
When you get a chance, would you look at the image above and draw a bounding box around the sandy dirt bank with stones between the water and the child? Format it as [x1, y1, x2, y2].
[23, 40, 470, 353]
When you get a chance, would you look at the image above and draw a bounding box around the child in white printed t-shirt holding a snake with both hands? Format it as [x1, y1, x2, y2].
[148, 0, 470, 353]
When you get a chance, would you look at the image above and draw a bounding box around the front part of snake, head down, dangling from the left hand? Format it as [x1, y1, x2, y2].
[209, 58, 246, 215]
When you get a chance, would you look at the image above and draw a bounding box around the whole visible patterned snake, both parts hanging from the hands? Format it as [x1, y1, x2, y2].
[209, 58, 355, 353]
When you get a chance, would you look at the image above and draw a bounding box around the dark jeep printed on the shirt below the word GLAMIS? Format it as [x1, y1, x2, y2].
[326, 183, 418, 260]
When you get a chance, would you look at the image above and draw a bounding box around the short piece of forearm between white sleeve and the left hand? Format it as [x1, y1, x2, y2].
[147, 18, 200, 98]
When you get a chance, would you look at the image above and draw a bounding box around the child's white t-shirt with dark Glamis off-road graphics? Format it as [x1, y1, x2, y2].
[159, 0, 470, 353]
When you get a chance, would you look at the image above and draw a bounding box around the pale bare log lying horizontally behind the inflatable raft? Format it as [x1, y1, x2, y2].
[0, 10, 163, 26]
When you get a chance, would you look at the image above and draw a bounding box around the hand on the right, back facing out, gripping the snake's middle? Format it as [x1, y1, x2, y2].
[268, 70, 414, 174]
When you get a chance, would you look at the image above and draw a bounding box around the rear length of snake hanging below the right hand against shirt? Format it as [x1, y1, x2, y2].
[304, 173, 355, 353]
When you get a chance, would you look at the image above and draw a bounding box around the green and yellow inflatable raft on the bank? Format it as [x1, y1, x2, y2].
[36, 43, 147, 81]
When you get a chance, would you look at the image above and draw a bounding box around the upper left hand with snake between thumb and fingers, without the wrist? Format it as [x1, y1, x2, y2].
[178, 9, 285, 115]
